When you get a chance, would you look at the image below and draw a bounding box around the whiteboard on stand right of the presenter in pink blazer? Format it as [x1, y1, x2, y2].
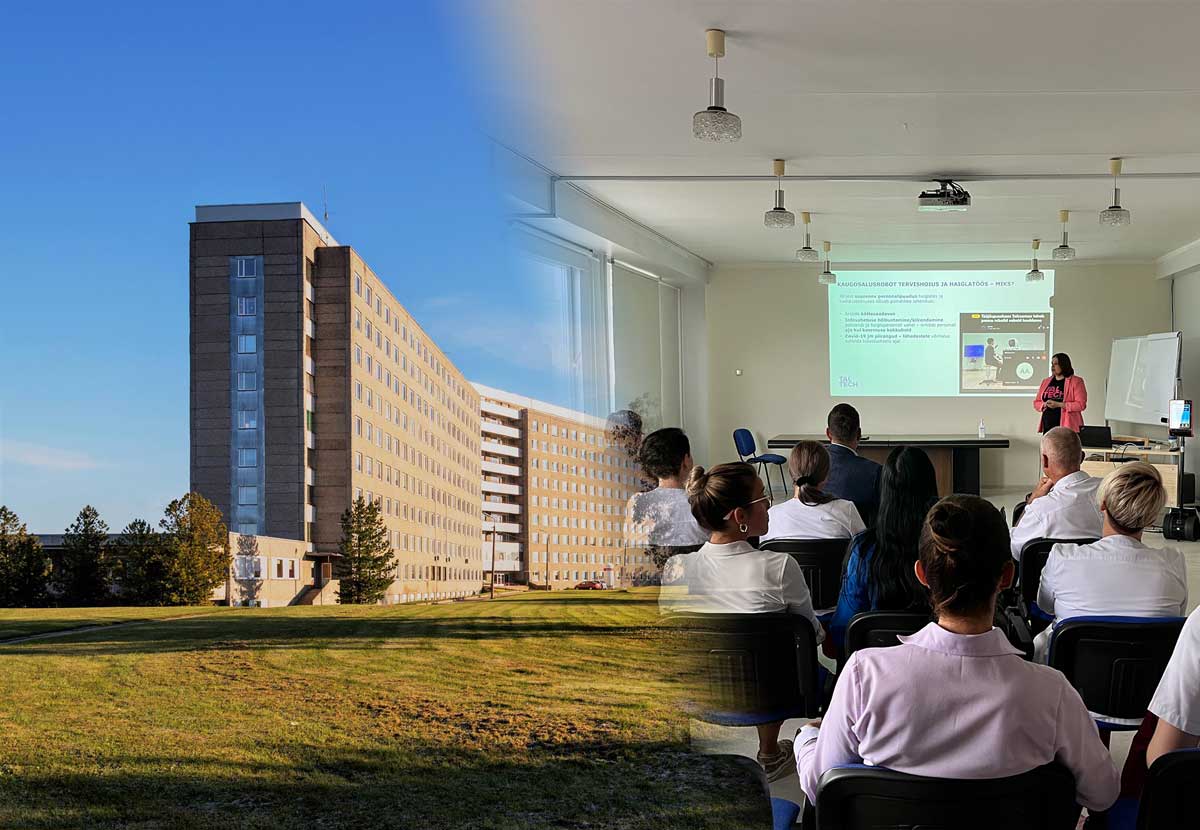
[1104, 331, 1183, 426]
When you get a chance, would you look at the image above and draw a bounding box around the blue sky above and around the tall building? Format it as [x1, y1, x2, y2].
[0, 0, 566, 533]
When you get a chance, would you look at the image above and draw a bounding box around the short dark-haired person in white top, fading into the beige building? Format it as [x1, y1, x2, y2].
[626, 427, 708, 567]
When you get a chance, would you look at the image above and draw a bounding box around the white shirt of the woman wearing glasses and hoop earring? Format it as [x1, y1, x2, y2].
[659, 542, 824, 643]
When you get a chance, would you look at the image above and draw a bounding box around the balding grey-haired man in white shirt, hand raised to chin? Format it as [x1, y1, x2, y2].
[1013, 427, 1103, 561]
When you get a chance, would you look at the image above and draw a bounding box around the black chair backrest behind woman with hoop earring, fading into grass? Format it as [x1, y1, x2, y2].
[670, 613, 820, 726]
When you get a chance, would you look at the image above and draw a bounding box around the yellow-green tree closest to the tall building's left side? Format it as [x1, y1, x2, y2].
[158, 493, 232, 606]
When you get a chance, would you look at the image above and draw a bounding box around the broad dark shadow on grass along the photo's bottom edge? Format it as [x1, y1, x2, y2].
[0, 741, 770, 830]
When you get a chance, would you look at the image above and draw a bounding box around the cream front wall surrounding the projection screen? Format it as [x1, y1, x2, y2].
[707, 263, 1166, 489]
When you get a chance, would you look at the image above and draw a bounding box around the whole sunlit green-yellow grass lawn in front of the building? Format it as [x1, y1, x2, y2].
[0, 590, 770, 830]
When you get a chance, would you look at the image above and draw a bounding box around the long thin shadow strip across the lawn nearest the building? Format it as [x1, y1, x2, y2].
[0, 613, 676, 655]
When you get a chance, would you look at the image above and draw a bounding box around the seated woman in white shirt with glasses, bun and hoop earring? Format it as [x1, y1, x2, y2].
[660, 463, 823, 781]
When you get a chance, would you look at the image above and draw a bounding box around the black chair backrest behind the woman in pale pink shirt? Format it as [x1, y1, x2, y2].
[816, 764, 1080, 830]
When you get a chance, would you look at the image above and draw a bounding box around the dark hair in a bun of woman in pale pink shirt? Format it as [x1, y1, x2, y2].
[920, 495, 1013, 617]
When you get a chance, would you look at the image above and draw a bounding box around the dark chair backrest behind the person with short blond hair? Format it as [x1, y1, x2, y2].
[1048, 617, 1184, 718]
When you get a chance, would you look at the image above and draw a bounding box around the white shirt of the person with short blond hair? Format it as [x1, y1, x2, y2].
[1034, 536, 1188, 662]
